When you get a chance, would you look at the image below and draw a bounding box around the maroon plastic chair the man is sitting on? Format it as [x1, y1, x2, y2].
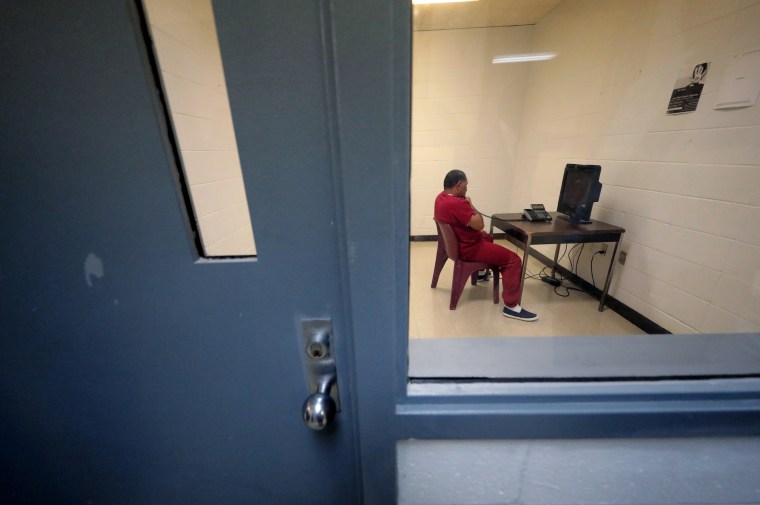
[430, 221, 499, 310]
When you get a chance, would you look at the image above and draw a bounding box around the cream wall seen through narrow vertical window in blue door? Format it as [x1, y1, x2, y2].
[144, 0, 256, 256]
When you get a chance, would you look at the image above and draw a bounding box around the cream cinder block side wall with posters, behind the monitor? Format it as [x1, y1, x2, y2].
[412, 0, 760, 333]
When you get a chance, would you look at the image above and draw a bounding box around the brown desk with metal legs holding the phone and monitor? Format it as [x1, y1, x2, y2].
[491, 212, 625, 312]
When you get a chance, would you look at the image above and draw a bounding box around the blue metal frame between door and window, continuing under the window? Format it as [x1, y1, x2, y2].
[331, 0, 760, 505]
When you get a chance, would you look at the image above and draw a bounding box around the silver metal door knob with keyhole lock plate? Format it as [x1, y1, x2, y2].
[302, 319, 340, 430]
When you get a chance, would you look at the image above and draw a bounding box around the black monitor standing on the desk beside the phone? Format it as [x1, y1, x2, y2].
[557, 163, 602, 224]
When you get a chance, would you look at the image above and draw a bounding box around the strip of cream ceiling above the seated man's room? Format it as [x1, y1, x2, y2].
[412, 0, 562, 32]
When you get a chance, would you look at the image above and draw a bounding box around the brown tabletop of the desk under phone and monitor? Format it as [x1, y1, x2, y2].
[491, 212, 625, 244]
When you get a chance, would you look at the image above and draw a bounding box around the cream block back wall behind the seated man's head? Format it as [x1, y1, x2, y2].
[411, 26, 533, 235]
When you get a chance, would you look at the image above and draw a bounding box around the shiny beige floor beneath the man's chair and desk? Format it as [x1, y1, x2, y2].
[409, 241, 644, 339]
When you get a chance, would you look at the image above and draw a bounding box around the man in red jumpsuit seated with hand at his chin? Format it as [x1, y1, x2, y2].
[434, 170, 538, 321]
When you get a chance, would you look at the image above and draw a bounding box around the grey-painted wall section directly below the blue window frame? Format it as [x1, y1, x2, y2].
[398, 437, 760, 505]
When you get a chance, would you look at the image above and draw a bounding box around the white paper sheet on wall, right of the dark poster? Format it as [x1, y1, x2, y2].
[715, 49, 760, 109]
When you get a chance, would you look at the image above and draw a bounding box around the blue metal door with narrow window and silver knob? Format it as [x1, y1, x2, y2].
[0, 0, 378, 504]
